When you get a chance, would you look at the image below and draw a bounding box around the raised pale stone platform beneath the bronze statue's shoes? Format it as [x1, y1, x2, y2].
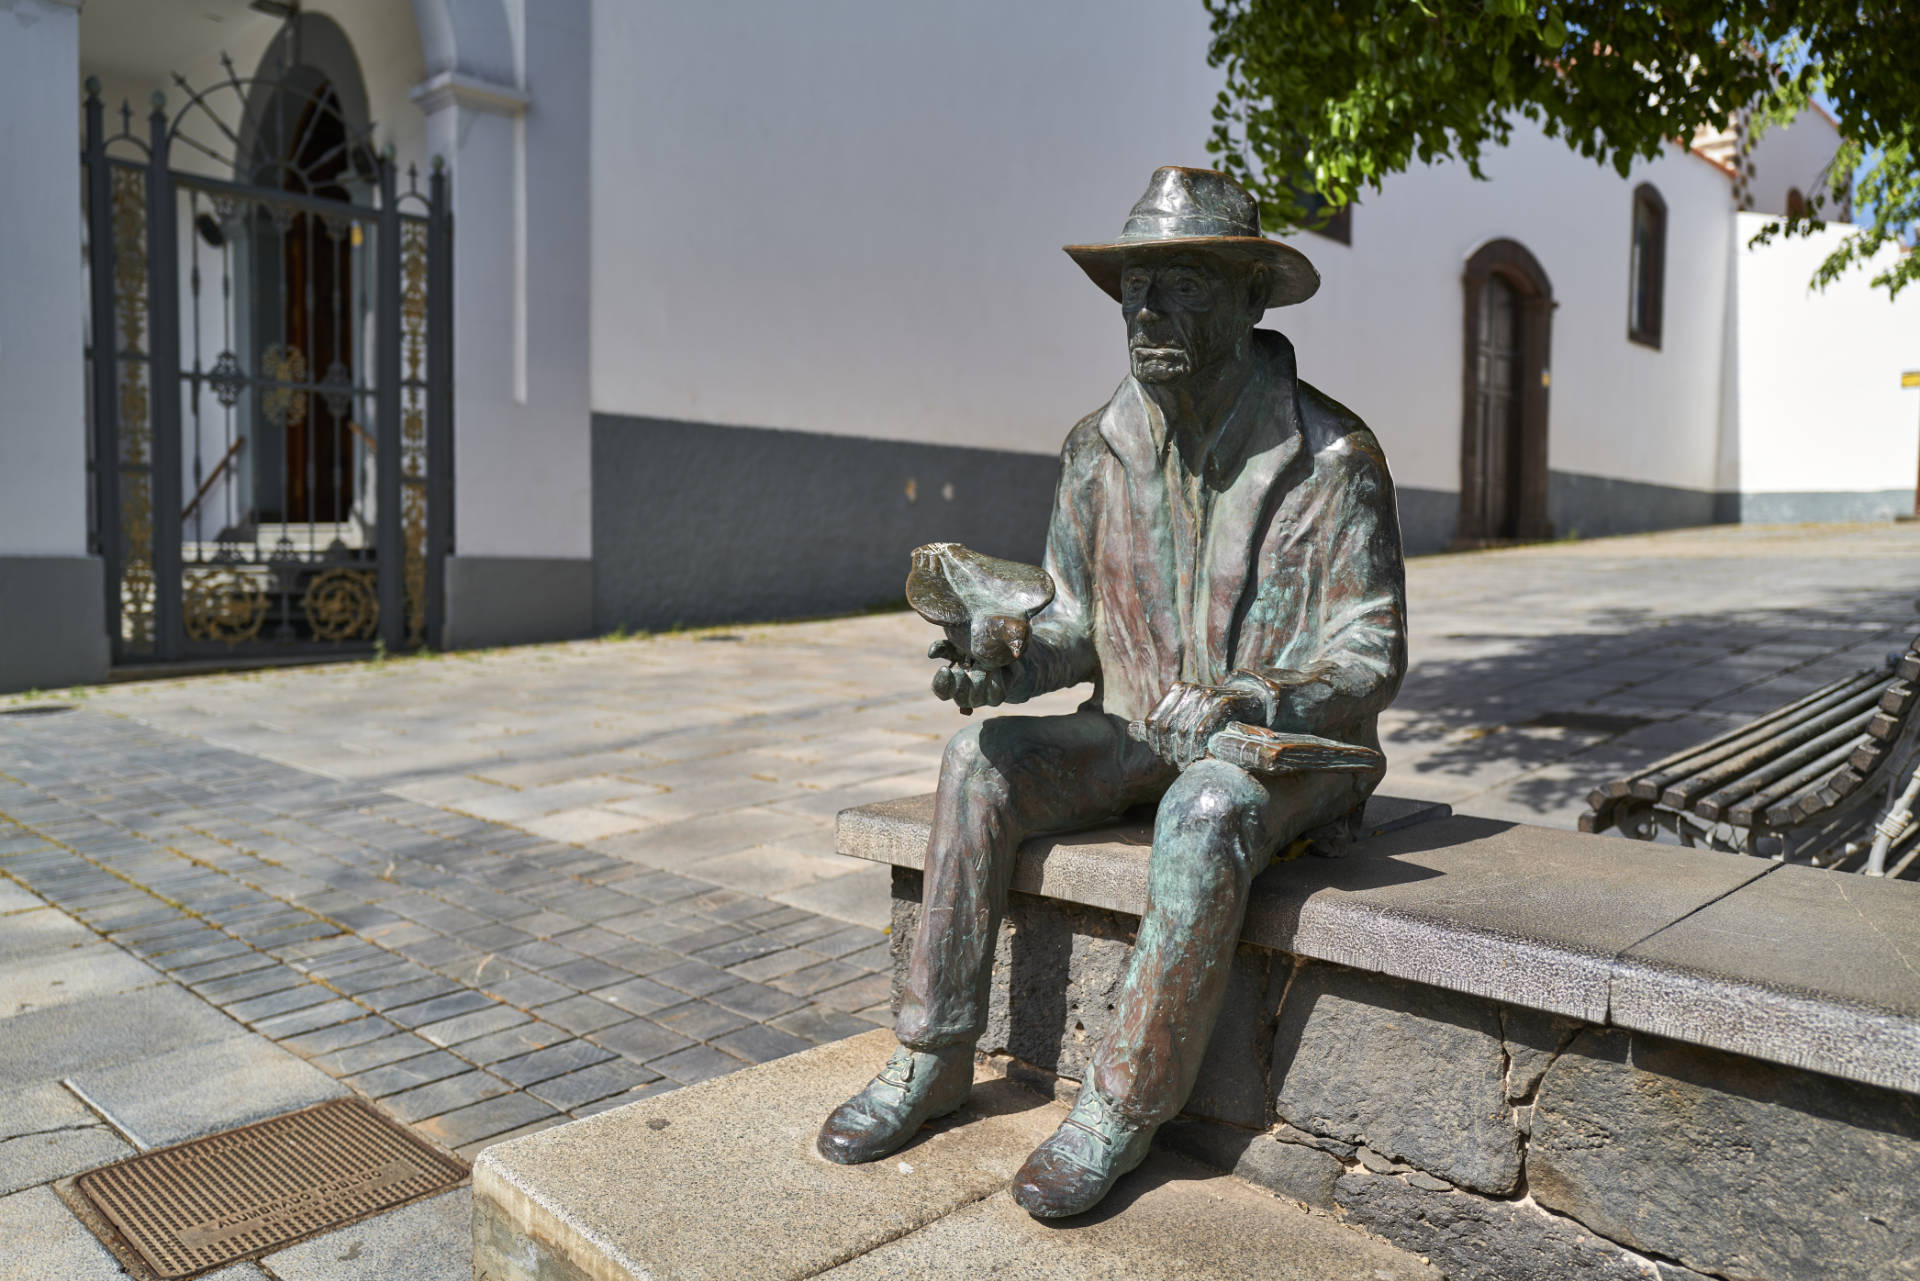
[474, 1031, 1440, 1281]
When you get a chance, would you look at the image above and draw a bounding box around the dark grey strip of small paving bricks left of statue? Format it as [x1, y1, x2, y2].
[0, 711, 887, 1154]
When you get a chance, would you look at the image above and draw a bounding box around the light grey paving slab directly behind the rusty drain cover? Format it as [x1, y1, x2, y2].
[67, 1035, 348, 1148]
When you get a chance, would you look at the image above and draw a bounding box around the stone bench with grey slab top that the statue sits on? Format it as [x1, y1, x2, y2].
[839, 797, 1920, 1281]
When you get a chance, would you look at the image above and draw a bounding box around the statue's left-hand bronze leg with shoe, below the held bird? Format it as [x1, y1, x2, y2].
[818, 713, 1171, 1164]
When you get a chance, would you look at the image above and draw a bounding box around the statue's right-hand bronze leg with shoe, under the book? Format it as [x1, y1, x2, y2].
[1014, 761, 1363, 1218]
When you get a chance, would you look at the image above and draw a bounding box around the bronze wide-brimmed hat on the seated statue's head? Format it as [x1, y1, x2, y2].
[1066, 165, 1319, 307]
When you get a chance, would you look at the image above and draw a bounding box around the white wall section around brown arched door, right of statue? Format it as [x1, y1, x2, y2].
[1290, 123, 1732, 490]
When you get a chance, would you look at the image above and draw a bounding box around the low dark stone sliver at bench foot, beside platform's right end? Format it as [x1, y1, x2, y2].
[1334, 1172, 1653, 1281]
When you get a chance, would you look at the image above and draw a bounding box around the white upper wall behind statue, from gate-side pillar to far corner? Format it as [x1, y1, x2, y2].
[591, 0, 1766, 514]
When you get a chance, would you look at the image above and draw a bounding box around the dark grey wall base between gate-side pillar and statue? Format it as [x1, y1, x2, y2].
[593, 413, 1060, 632]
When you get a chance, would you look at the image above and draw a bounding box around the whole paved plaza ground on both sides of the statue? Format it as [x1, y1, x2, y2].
[0, 526, 1920, 1281]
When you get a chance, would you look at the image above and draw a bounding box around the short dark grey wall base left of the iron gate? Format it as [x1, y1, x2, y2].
[0, 555, 109, 693]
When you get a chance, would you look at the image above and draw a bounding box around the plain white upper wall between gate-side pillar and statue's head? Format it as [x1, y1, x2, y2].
[591, 0, 1219, 453]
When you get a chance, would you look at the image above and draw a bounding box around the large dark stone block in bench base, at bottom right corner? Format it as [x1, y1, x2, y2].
[1528, 1029, 1920, 1281]
